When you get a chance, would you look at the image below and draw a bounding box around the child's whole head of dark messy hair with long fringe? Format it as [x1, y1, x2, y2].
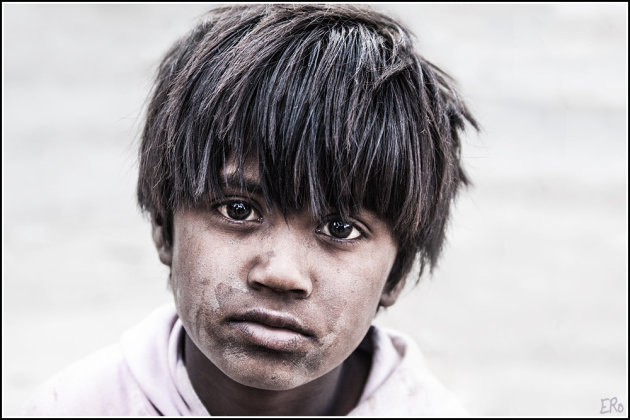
[137, 4, 477, 290]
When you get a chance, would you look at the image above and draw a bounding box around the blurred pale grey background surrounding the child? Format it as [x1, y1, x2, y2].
[2, 3, 628, 416]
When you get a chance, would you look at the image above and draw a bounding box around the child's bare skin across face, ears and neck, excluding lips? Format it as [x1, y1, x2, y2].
[153, 159, 403, 415]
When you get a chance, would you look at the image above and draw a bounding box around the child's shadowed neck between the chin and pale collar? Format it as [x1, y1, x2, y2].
[183, 334, 371, 416]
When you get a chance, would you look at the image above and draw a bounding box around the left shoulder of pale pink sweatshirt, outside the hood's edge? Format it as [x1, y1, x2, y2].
[23, 345, 156, 416]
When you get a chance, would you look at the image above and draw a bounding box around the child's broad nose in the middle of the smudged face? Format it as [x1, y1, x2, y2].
[247, 225, 313, 299]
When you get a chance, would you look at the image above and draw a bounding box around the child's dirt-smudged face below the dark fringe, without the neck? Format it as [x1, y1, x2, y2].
[160, 158, 398, 390]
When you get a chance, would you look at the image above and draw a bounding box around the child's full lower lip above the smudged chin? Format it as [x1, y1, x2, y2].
[233, 321, 310, 351]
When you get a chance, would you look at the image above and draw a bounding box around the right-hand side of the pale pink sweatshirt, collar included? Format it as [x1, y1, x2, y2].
[350, 328, 467, 417]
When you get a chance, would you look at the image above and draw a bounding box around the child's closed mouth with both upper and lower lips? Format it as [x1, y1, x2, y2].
[227, 308, 315, 351]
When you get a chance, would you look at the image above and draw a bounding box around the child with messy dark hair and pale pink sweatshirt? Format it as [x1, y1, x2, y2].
[27, 4, 477, 416]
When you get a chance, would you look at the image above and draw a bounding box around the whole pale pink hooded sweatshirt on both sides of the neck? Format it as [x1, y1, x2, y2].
[23, 304, 466, 416]
